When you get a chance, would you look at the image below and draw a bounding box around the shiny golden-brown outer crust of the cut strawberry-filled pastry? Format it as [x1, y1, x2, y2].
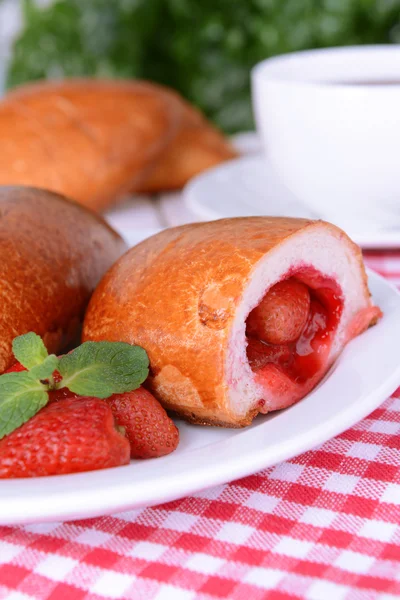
[83, 217, 374, 426]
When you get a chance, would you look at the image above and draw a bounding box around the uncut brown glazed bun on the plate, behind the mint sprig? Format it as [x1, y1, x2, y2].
[0, 187, 125, 373]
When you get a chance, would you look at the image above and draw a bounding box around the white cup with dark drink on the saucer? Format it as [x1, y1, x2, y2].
[252, 45, 400, 230]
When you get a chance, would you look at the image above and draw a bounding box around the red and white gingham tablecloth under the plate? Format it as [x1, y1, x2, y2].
[0, 252, 400, 600]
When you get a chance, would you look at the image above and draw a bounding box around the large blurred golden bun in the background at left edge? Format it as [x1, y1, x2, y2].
[0, 79, 181, 210]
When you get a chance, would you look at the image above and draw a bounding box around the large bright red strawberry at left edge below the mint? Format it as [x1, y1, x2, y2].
[0, 398, 130, 478]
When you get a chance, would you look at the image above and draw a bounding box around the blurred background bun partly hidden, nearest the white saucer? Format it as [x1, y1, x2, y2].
[136, 90, 238, 194]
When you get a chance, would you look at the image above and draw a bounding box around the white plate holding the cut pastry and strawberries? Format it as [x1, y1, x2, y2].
[0, 273, 400, 524]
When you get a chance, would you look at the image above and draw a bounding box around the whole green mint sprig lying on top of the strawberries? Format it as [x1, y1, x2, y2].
[0, 332, 149, 439]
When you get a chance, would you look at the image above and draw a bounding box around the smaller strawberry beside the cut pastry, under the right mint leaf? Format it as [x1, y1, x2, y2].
[107, 387, 179, 458]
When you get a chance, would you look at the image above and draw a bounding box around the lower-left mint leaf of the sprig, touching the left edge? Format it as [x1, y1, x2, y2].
[0, 371, 49, 439]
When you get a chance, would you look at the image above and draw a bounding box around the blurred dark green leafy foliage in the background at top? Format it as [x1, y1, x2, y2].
[8, 0, 400, 132]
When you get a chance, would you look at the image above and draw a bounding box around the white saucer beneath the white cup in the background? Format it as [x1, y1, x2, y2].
[184, 153, 400, 248]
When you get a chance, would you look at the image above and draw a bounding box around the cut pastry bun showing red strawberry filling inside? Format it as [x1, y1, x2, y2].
[84, 217, 381, 427]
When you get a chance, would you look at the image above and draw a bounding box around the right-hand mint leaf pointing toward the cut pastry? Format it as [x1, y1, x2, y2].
[58, 342, 149, 398]
